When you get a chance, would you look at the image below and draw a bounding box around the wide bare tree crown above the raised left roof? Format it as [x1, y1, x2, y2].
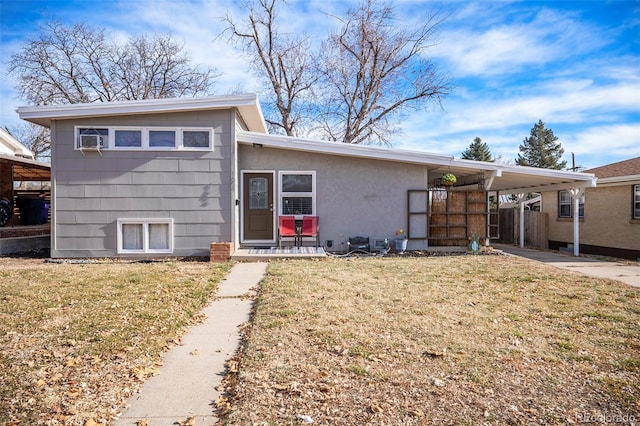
[9, 21, 217, 105]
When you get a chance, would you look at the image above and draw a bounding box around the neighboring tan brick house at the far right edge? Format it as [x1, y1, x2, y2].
[542, 157, 640, 260]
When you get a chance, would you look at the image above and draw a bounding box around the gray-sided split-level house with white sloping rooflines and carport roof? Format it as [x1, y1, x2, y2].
[18, 95, 595, 258]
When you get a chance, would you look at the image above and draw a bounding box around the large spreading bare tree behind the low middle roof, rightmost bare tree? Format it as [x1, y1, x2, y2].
[319, 0, 451, 144]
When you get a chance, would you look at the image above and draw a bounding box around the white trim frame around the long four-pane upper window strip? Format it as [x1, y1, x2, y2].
[74, 125, 214, 151]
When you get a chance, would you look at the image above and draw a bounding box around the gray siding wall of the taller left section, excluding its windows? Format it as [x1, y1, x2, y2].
[52, 111, 236, 257]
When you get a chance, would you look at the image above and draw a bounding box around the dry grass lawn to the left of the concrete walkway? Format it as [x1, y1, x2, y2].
[0, 258, 229, 425]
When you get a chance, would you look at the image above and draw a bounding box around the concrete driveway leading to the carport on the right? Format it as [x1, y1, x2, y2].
[492, 244, 640, 287]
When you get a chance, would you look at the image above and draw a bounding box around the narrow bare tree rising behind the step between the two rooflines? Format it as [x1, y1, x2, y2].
[225, 0, 317, 136]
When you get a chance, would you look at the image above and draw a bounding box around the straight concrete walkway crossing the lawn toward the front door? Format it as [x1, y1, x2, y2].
[113, 263, 268, 426]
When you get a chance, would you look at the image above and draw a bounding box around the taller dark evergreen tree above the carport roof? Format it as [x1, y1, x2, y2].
[516, 120, 567, 170]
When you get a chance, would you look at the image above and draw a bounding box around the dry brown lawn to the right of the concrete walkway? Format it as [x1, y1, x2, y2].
[219, 256, 640, 425]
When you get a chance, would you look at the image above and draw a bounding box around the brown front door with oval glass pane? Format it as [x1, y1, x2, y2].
[242, 172, 275, 241]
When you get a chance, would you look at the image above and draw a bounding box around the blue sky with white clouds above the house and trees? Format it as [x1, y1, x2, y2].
[0, 0, 640, 168]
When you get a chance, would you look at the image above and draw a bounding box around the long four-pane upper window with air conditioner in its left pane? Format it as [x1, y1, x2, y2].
[75, 126, 213, 150]
